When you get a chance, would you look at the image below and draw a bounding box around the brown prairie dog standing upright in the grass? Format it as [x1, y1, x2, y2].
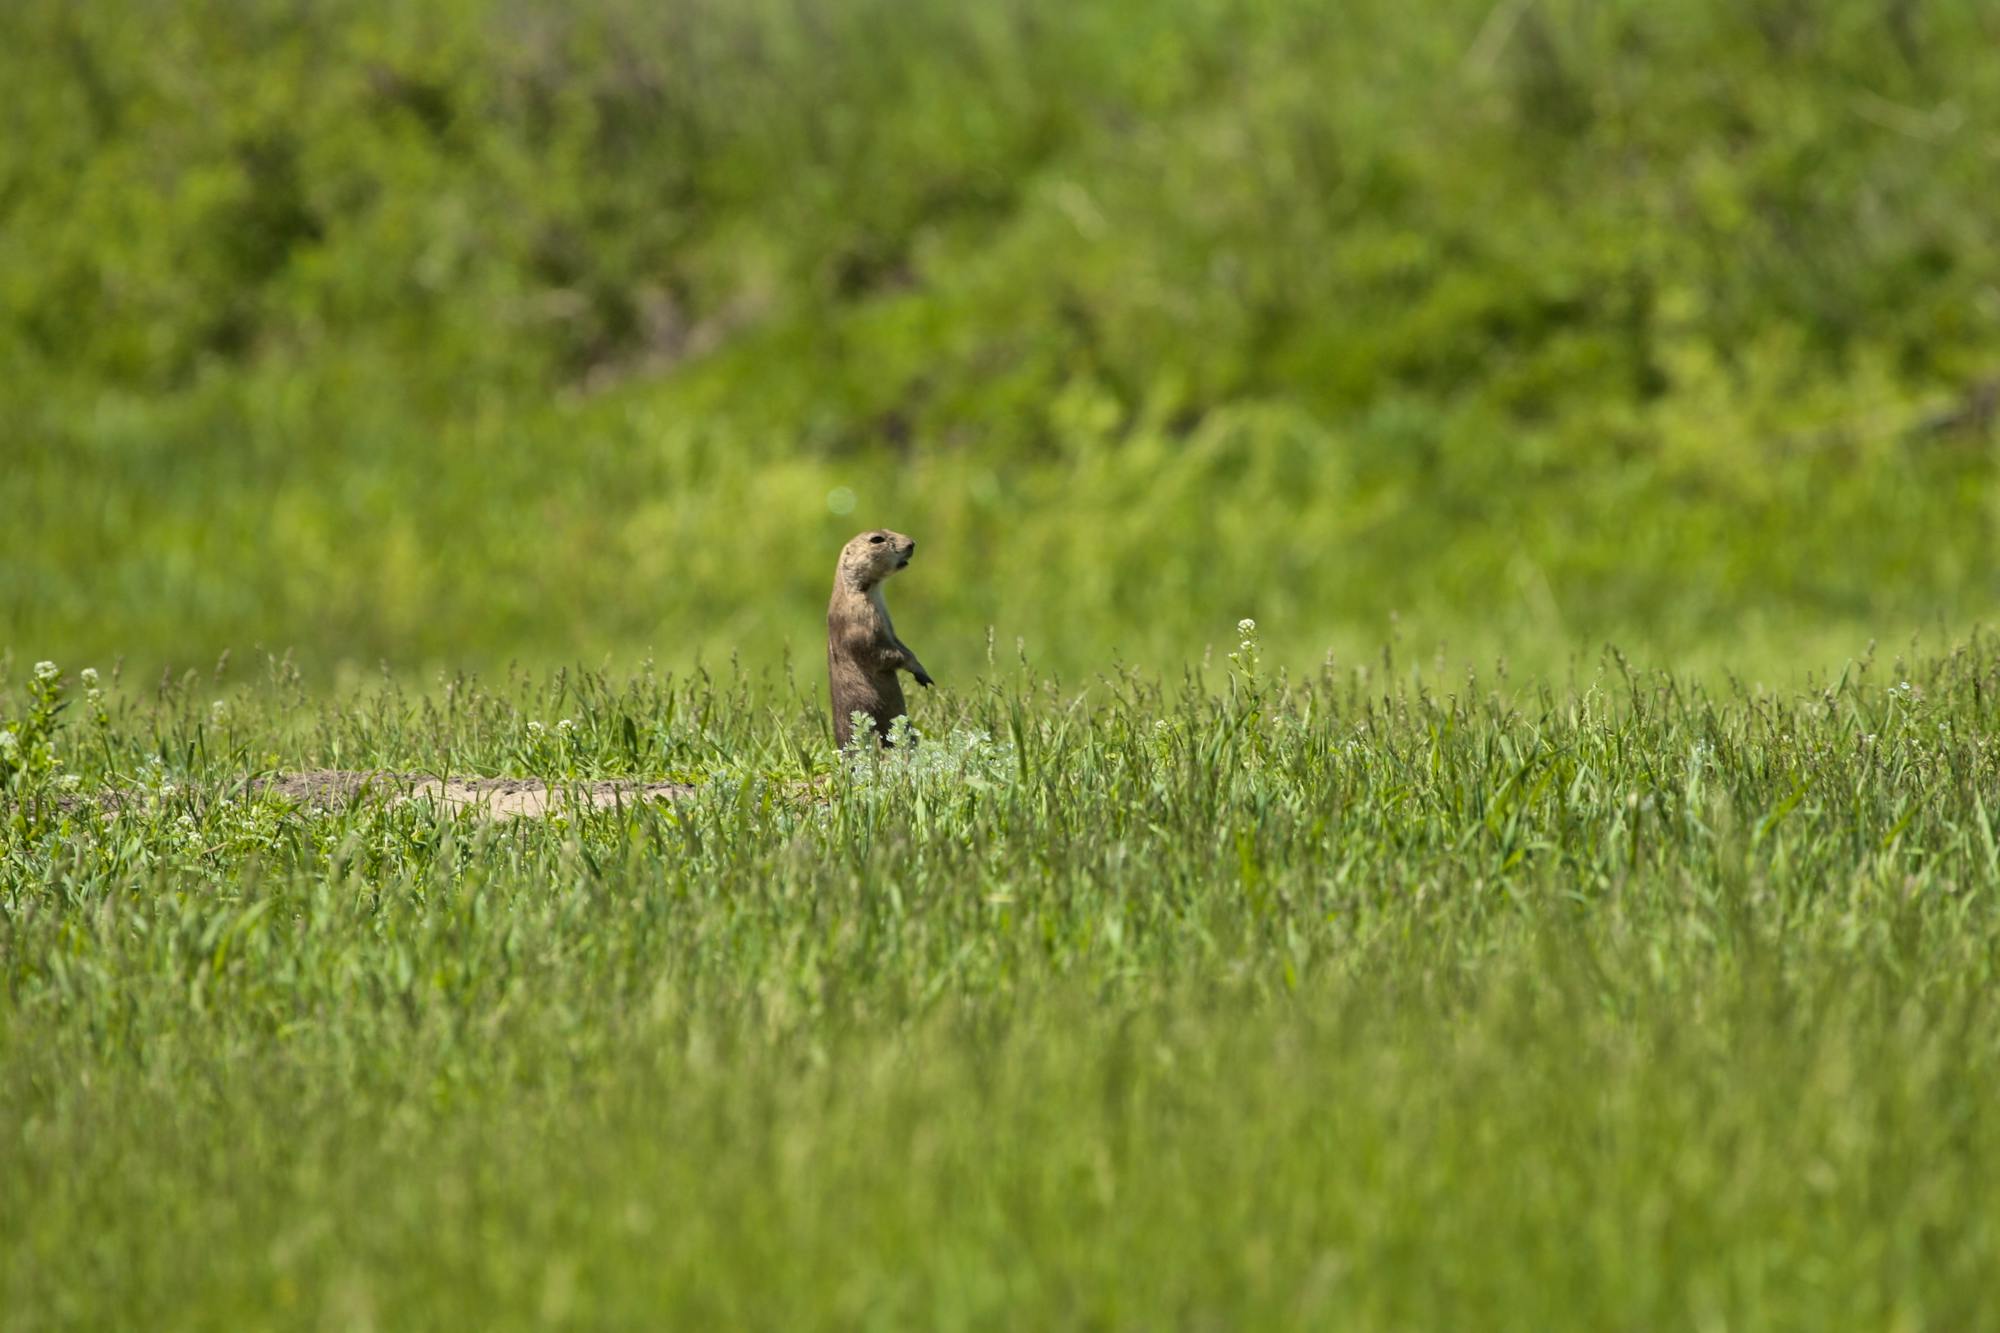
[826, 528, 930, 749]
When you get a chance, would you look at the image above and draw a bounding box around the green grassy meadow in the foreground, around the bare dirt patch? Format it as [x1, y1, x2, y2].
[0, 632, 2000, 1329]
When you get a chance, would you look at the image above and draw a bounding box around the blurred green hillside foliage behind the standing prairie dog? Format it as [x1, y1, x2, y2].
[0, 0, 2000, 681]
